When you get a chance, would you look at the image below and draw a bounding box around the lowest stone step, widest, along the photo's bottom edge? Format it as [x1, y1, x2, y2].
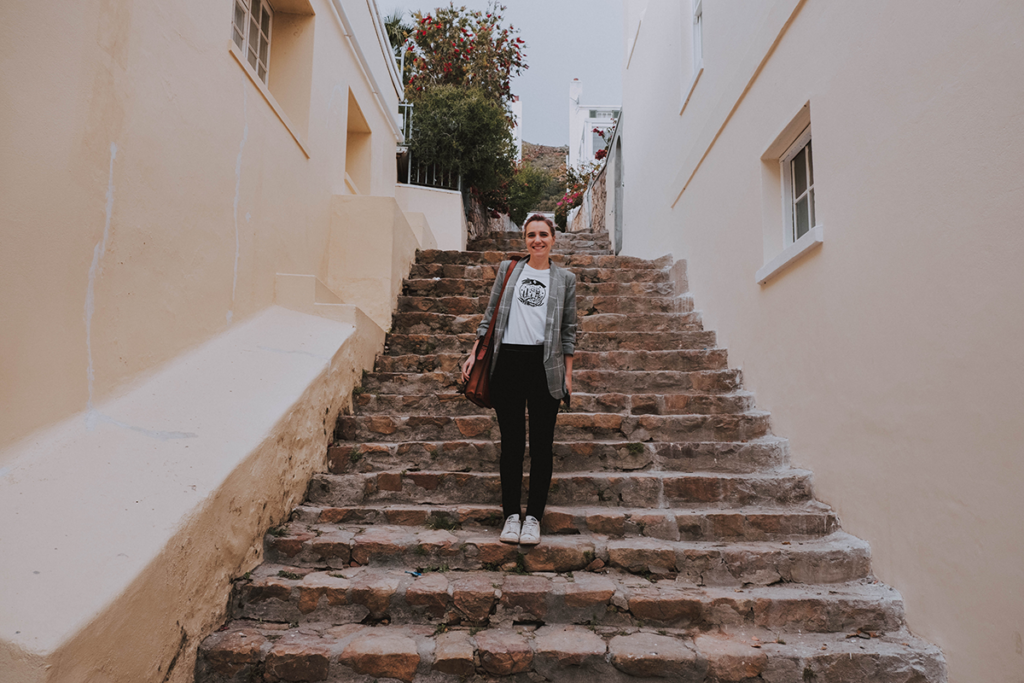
[196, 621, 946, 683]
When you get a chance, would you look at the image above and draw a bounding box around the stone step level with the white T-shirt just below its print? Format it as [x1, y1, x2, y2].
[391, 310, 701, 336]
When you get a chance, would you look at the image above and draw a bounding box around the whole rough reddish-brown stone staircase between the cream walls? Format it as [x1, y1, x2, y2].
[196, 233, 946, 683]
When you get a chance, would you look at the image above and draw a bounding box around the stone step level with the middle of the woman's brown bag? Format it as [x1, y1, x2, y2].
[360, 369, 740, 395]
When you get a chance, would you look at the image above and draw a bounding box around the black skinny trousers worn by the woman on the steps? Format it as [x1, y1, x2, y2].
[490, 344, 558, 519]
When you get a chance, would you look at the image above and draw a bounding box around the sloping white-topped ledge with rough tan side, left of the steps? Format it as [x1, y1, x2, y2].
[0, 305, 384, 683]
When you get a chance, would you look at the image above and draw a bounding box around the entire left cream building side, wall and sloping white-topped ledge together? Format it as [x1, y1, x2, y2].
[0, 0, 434, 683]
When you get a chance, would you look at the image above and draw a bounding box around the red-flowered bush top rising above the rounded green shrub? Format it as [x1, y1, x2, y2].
[406, 2, 526, 105]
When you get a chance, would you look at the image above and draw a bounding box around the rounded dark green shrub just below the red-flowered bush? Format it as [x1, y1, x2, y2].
[410, 85, 515, 193]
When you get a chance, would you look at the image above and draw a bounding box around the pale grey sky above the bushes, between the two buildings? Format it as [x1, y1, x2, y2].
[377, 0, 626, 146]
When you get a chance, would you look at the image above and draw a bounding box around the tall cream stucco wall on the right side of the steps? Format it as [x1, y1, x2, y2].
[621, 0, 1024, 683]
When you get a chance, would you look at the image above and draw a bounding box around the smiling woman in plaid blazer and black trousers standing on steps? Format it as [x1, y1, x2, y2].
[462, 214, 577, 546]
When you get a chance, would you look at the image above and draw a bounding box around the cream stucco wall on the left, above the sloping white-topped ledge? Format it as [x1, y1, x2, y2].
[0, 0, 397, 454]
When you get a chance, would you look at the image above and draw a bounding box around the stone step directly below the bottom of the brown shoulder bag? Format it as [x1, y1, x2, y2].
[335, 411, 768, 442]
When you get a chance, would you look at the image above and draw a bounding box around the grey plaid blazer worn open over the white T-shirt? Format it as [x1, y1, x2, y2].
[476, 259, 577, 398]
